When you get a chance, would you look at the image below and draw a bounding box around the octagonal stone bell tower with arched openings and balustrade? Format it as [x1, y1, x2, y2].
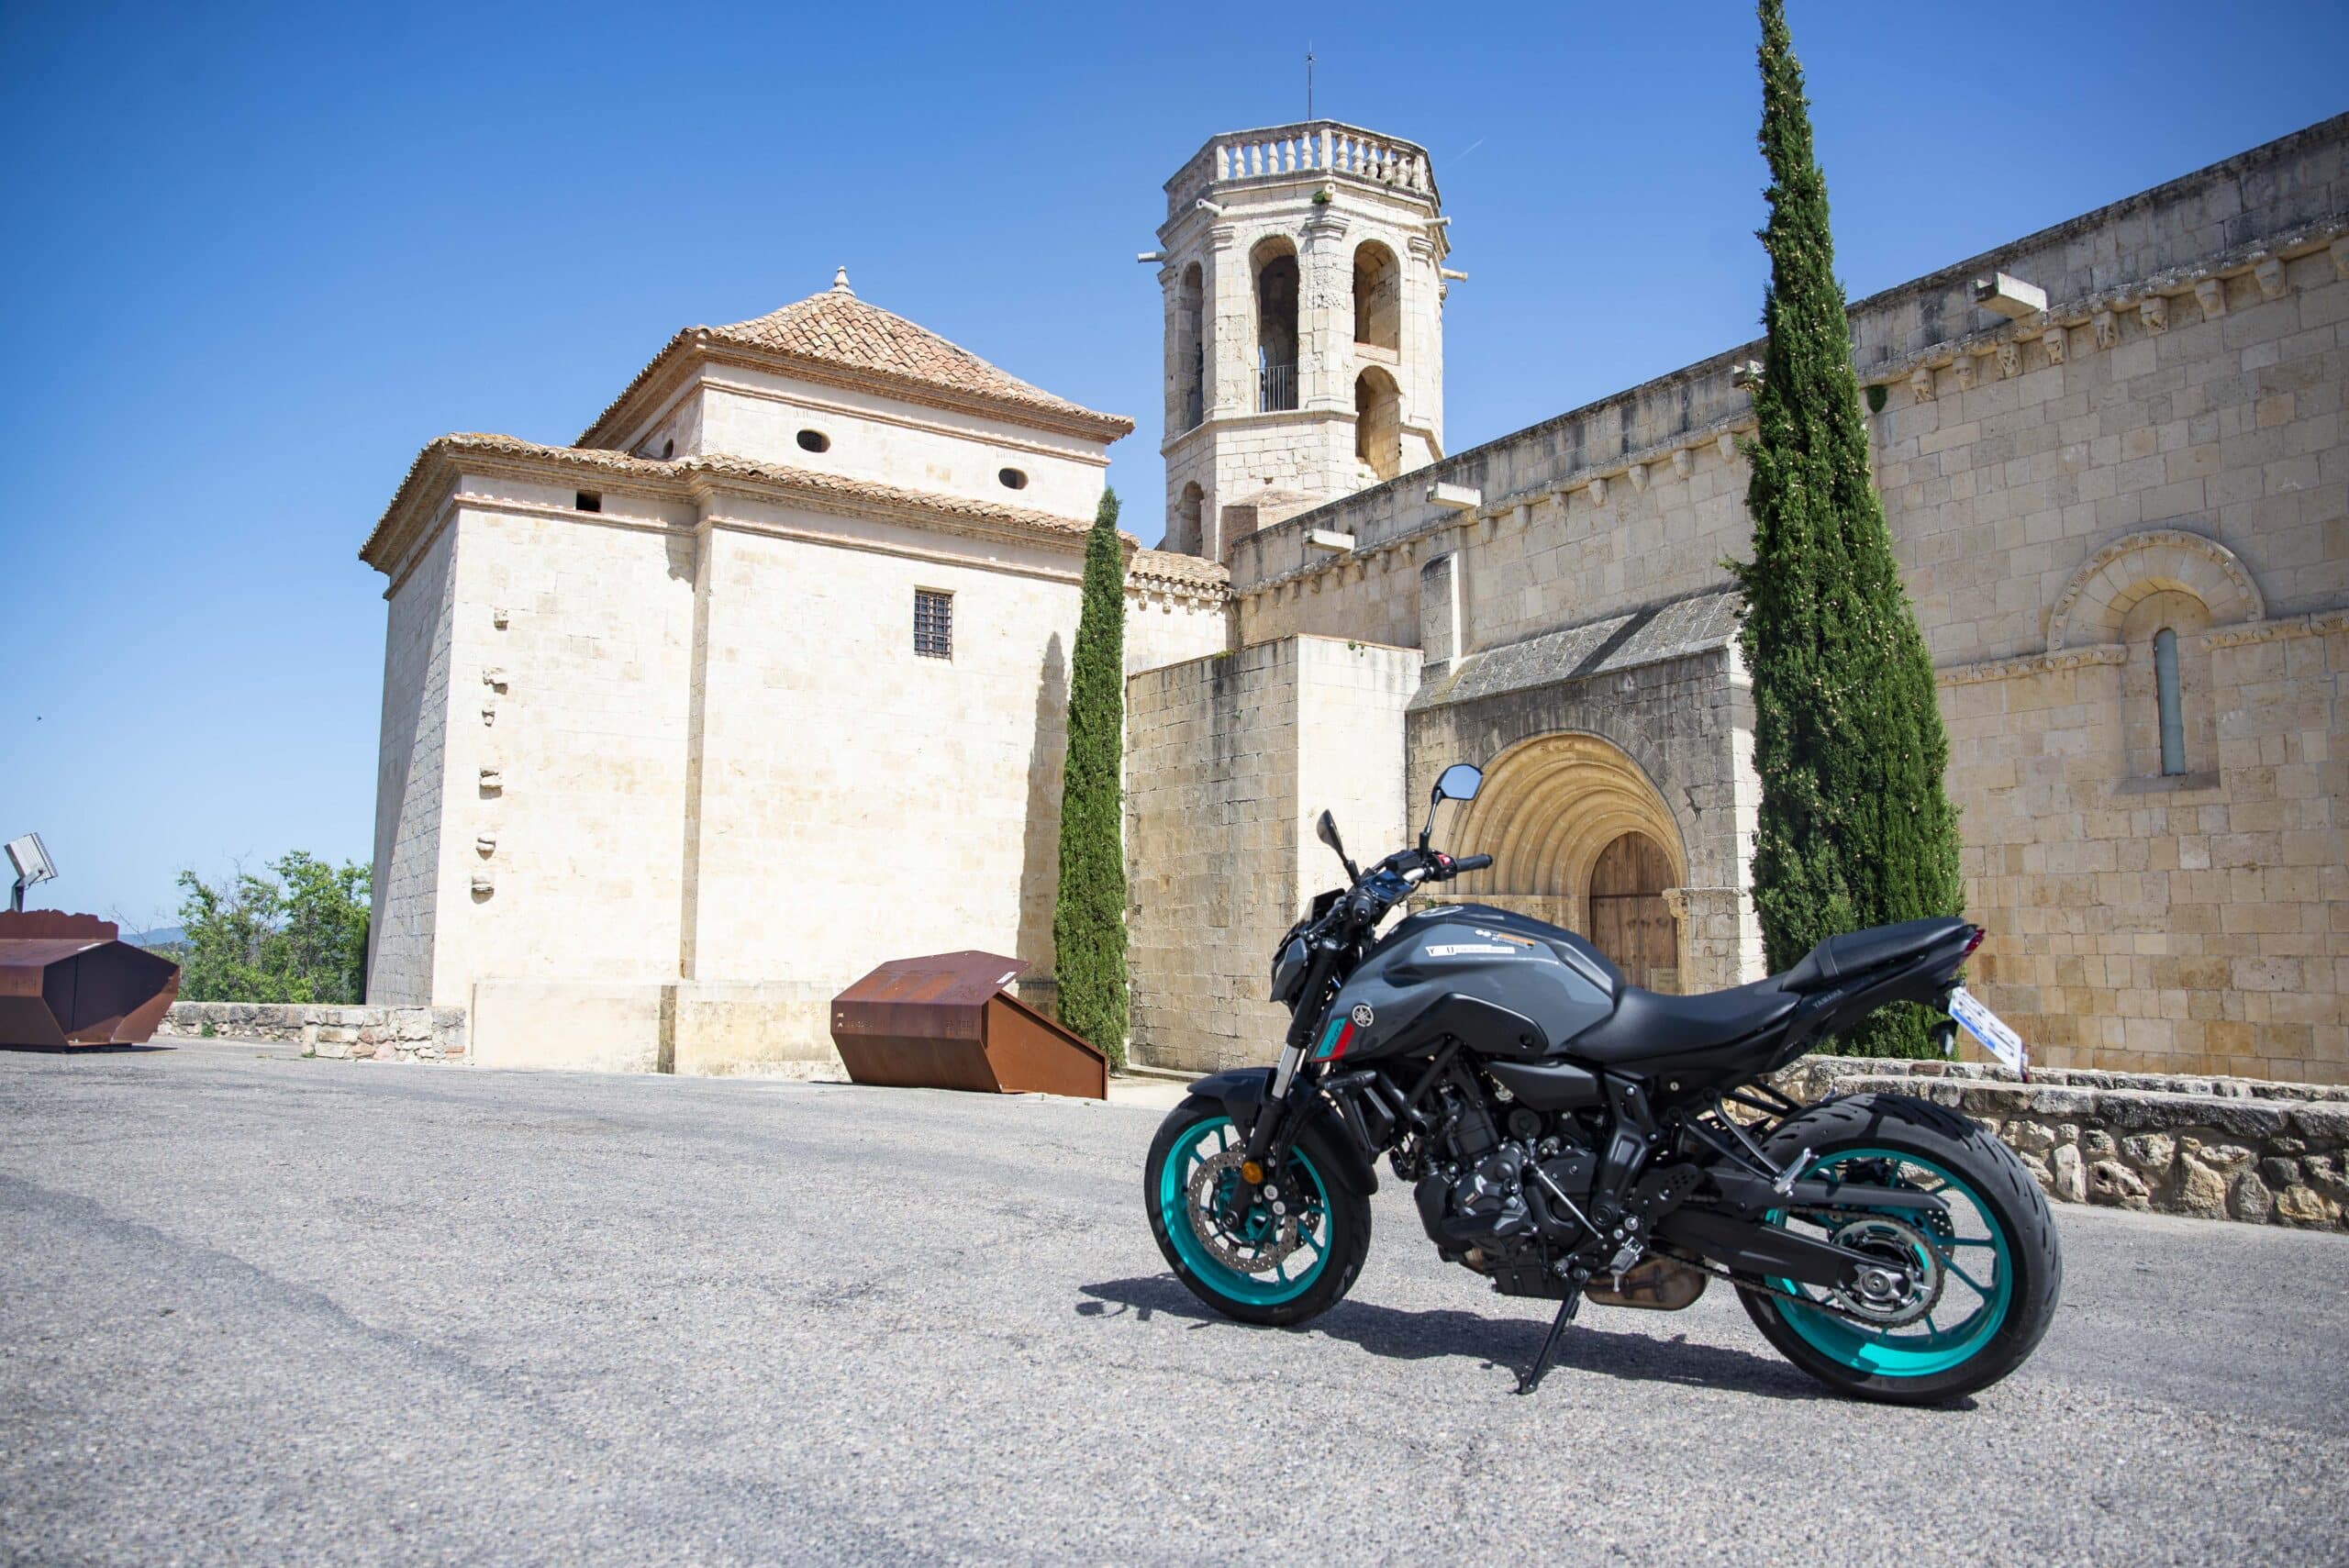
[1146, 119, 1450, 561]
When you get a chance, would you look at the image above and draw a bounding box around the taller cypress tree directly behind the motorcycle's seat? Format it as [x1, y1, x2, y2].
[1736, 0, 1964, 1056]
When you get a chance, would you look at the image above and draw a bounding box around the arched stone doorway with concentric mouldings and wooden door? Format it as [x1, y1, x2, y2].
[1444, 735, 1689, 991]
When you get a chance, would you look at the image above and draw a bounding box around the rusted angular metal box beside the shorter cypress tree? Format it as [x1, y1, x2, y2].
[831, 953, 1108, 1101]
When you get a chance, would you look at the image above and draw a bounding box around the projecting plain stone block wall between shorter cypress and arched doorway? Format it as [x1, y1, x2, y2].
[1125, 639, 1419, 1073]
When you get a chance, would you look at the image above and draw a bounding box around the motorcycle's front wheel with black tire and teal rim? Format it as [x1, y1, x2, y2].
[1141, 1094, 1369, 1329]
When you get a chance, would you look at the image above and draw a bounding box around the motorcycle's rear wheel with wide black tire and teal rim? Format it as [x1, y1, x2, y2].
[1738, 1094, 2063, 1404]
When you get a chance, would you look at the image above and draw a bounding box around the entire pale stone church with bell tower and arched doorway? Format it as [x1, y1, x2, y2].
[362, 115, 2349, 1082]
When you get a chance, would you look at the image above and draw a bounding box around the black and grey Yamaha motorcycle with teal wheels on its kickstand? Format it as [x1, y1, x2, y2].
[1144, 765, 2063, 1404]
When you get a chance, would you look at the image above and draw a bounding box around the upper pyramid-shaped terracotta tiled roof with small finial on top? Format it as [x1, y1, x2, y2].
[580, 279, 1134, 441]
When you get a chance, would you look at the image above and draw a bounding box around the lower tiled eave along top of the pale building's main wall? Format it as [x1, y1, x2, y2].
[360, 432, 1130, 571]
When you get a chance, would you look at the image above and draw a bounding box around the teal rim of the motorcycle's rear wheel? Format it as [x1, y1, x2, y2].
[1771, 1148, 2015, 1378]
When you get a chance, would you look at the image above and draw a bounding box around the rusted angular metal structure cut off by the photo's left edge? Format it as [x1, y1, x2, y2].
[0, 908, 179, 1050]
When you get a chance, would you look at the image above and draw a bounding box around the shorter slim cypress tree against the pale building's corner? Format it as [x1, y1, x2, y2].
[1052, 488, 1125, 1068]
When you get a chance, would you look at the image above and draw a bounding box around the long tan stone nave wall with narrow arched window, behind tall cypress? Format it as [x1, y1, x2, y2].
[1174, 117, 2349, 1082]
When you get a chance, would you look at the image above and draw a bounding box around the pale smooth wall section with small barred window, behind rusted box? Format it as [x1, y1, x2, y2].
[676, 500, 1083, 1071]
